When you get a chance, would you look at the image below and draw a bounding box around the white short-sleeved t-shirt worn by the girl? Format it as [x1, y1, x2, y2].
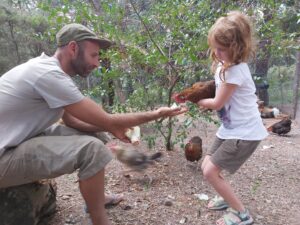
[215, 63, 268, 140]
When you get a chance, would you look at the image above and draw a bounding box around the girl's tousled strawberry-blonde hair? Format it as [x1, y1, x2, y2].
[208, 11, 256, 80]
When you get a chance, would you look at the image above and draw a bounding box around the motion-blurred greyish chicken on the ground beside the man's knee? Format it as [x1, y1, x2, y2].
[109, 145, 162, 172]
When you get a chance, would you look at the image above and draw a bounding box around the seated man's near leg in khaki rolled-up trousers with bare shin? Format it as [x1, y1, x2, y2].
[0, 136, 112, 225]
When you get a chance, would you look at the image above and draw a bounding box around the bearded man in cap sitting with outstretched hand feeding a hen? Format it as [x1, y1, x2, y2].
[0, 24, 186, 225]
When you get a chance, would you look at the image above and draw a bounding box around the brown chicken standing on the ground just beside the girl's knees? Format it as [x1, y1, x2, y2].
[184, 136, 202, 162]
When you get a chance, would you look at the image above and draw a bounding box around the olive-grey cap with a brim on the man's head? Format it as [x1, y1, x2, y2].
[56, 23, 112, 49]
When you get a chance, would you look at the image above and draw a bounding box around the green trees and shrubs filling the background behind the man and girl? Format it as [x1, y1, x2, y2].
[0, 0, 300, 150]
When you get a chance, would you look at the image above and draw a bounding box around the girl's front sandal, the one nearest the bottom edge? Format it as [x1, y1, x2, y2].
[216, 208, 253, 225]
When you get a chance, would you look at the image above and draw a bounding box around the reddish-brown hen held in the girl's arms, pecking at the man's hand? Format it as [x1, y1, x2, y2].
[172, 80, 216, 103]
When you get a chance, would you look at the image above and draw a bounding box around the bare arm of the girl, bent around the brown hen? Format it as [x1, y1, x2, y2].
[197, 82, 237, 110]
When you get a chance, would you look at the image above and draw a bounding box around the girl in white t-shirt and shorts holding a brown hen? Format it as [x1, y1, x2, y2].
[198, 11, 268, 225]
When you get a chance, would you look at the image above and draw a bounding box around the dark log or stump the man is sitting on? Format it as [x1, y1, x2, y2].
[0, 180, 56, 225]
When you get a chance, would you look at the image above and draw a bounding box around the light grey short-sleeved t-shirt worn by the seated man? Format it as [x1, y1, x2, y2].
[0, 53, 84, 156]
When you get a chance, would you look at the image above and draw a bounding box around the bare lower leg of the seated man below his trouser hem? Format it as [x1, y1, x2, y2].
[79, 169, 110, 225]
